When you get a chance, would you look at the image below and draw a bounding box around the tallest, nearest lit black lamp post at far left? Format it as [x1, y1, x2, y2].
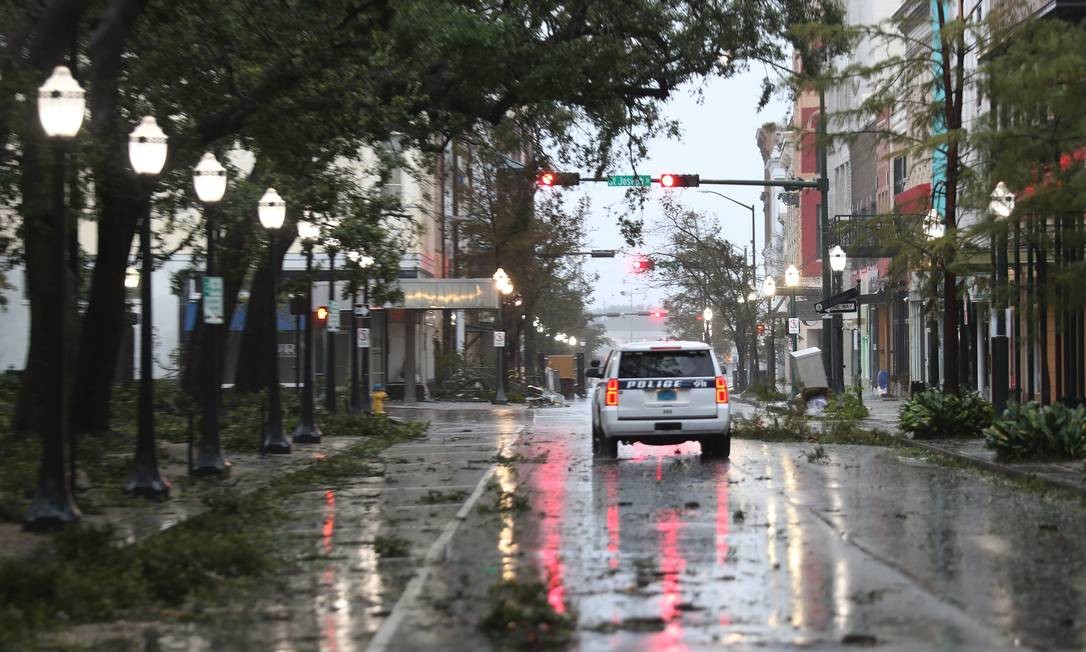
[23, 65, 87, 531]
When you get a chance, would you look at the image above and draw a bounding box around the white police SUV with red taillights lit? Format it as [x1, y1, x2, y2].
[585, 341, 732, 457]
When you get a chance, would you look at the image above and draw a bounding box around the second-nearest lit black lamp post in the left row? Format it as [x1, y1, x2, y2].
[125, 115, 169, 497]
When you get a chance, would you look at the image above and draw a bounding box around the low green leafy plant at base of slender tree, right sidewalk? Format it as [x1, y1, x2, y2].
[899, 389, 992, 439]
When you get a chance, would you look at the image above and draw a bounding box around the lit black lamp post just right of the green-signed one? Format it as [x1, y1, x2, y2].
[256, 188, 290, 454]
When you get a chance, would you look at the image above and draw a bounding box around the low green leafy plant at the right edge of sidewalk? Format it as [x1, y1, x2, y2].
[984, 402, 1086, 462]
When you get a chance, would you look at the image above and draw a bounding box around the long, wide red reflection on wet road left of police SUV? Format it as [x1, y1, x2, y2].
[534, 441, 569, 614]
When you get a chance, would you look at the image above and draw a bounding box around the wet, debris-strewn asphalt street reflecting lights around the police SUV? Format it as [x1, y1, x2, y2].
[123, 402, 1086, 652]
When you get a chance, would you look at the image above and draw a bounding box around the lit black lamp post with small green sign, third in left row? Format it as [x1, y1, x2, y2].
[191, 152, 227, 475]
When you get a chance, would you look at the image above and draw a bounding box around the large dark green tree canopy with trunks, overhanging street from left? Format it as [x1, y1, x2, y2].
[0, 0, 833, 430]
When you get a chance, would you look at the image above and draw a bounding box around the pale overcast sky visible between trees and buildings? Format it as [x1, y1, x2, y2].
[561, 71, 788, 315]
